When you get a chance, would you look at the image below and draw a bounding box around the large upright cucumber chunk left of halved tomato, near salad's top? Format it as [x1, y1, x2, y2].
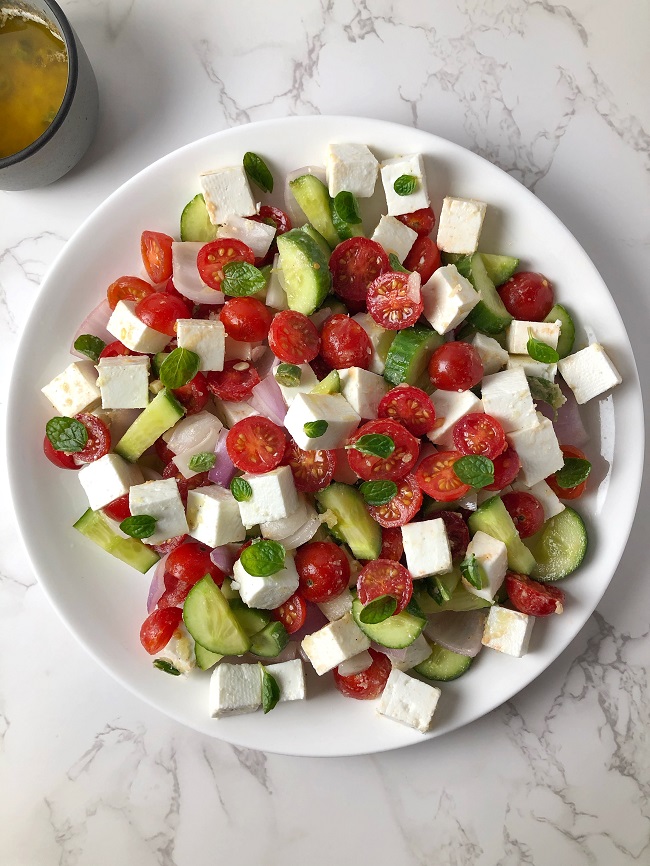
[278, 229, 332, 316]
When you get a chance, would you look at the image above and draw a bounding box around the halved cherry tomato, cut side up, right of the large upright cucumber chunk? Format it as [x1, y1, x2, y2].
[330, 238, 390, 313]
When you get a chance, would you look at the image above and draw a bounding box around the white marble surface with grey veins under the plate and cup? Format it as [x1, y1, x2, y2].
[0, 0, 650, 866]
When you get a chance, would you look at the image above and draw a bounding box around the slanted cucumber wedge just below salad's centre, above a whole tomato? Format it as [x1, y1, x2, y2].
[316, 482, 381, 559]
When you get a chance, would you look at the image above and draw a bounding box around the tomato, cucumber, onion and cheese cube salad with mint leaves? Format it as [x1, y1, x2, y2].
[42, 143, 621, 732]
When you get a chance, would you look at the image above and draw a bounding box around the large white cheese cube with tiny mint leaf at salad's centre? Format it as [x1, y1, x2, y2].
[284, 394, 361, 451]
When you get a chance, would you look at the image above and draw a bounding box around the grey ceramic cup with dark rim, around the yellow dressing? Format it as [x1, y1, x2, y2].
[0, 0, 98, 190]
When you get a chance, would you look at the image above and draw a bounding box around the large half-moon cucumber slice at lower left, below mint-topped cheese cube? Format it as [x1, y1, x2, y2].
[183, 574, 250, 656]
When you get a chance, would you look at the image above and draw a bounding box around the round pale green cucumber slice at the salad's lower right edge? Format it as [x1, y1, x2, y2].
[529, 506, 588, 581]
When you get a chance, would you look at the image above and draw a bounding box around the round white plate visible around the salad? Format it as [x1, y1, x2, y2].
[8, 117, 643, 756]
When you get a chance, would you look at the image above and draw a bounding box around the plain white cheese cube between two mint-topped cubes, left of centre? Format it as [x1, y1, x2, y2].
[187, 484, 246, 547]
